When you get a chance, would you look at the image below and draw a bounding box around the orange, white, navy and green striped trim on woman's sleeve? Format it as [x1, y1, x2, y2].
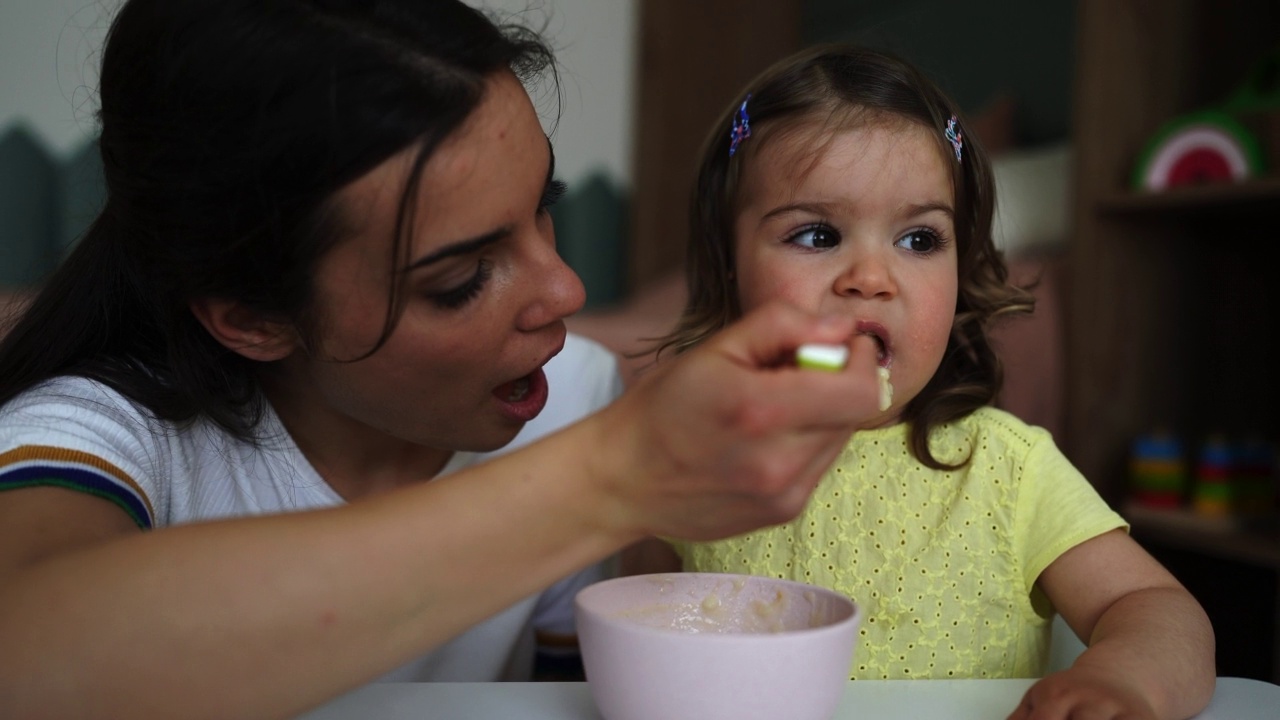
[0, 445, 155, 530]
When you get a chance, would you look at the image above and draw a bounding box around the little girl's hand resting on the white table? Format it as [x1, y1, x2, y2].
[1009, 666, 1158, 720]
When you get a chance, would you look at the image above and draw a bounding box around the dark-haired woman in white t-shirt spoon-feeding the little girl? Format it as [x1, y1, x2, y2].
[0, 0, 877, 717]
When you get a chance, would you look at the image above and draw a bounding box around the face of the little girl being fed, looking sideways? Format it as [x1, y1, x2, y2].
[733, 120, 957, 424]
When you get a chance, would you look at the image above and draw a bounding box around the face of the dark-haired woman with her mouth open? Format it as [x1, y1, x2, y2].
[273, 73, 585, 452]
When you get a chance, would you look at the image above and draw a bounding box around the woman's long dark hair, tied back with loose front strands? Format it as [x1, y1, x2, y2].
[0, 0, 554, 439]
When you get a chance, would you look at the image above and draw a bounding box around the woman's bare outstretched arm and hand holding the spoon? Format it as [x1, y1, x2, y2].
[0, 302, 877, 719]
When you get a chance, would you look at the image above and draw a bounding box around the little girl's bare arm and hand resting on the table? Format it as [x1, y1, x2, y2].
[1010, 530, 1216, 720]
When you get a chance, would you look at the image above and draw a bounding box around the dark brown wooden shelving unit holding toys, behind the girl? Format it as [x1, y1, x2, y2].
[1064, 0, 1280, 682]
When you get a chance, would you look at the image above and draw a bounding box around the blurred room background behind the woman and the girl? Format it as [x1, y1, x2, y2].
[0, 0, 1280, 682]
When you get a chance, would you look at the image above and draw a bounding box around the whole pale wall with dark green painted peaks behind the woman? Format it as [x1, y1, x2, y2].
[0, 0, 637, 302]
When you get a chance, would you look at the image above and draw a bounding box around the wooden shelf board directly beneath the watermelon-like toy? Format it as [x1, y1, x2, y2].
[1097, 177, 1280, 217]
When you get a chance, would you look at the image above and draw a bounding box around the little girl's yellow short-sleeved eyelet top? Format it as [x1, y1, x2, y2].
[673, 407, 1128, 679]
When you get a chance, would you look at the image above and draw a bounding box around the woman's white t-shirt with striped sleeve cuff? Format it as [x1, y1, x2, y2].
[0, 334, 622, 682]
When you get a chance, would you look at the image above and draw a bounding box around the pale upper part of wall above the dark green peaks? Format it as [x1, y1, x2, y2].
[0, 0, 637, 184]
